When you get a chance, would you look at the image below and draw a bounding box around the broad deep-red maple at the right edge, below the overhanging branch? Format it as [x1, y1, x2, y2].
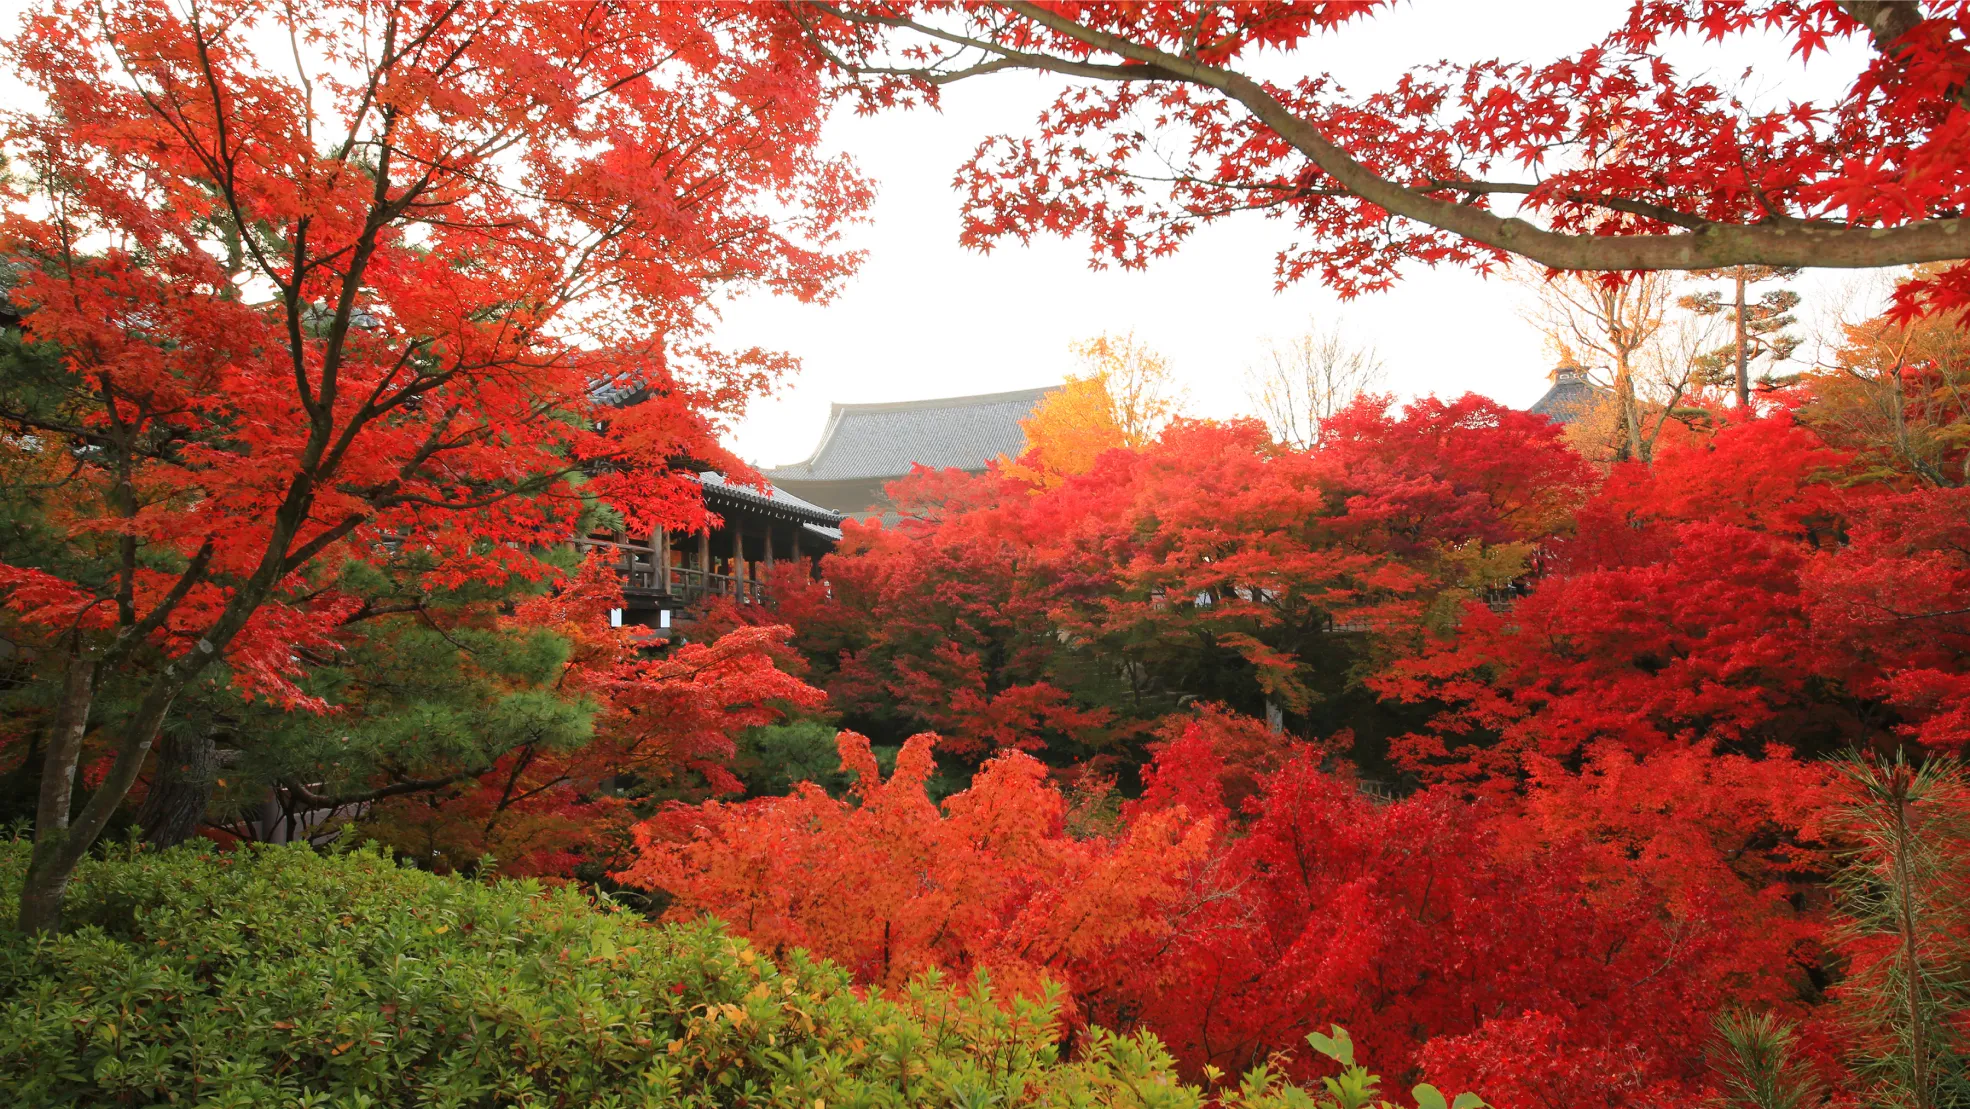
[1371, 412, 1970, 784]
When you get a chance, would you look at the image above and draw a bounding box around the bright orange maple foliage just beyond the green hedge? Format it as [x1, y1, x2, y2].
[617, 731, 1212, 1016]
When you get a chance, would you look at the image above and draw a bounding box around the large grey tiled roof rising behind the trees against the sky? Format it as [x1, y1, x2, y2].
[764, 388, 1052, 481]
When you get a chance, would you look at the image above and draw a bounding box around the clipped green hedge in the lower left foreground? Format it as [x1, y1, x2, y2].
[0, 843, 1434, 1109]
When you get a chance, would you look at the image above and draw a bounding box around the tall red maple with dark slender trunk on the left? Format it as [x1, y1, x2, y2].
[4, 0, 869, 928]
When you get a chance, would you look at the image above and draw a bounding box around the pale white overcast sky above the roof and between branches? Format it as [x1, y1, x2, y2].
[719, 0, 1891, 465]
